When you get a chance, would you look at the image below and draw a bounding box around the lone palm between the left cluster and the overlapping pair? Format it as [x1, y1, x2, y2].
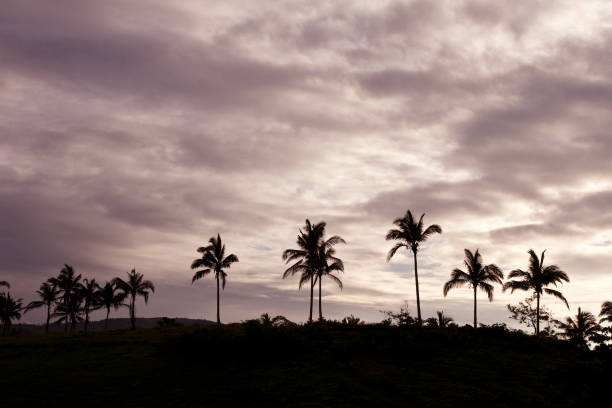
[191, 234, 239, 326]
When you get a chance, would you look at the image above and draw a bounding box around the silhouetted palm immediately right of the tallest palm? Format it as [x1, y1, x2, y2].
[442, 249, 504, 328]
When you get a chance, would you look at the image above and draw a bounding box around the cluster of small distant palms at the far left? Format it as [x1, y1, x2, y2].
[0, 265, 155, 334]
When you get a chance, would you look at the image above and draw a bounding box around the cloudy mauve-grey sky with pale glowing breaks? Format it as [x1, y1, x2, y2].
[0, 0, 612, 324]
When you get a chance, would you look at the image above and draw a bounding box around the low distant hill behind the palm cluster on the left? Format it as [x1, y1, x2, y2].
[13, 317, 216, 334]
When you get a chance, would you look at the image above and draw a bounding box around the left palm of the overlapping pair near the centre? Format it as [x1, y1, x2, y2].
[282, 219, 326, 323]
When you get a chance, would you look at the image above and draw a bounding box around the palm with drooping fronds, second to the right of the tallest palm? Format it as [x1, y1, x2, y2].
[503, 249, 569, 335]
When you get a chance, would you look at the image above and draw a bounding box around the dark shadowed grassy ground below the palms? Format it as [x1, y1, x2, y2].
[0, 323, 612, 407]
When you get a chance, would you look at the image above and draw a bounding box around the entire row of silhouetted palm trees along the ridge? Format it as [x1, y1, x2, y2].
[0, 210, 612, 350]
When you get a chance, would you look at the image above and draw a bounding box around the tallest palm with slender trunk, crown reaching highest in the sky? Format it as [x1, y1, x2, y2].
[386, 210, 442, 326]
